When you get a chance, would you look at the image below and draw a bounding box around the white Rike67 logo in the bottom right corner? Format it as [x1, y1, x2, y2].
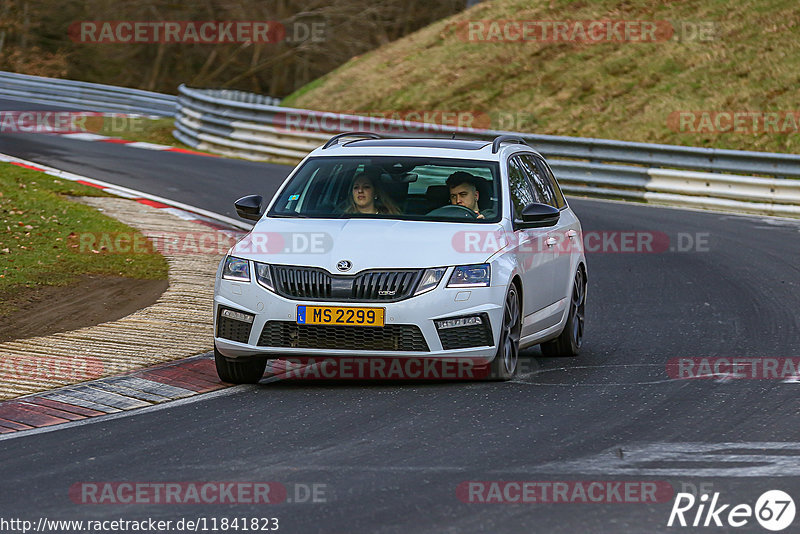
[667, 490, 795, 532]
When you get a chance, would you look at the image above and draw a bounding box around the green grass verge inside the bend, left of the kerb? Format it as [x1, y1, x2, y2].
[0, 163, 168, 316]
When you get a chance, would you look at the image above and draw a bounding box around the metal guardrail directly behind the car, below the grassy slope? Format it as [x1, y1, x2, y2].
[173, 85, 800, 217]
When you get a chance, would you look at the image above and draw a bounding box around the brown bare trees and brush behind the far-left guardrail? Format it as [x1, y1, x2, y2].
[0, 0, 466, 97]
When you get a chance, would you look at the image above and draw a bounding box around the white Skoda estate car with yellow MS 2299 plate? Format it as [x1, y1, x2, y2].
[214, 133, 587, 383]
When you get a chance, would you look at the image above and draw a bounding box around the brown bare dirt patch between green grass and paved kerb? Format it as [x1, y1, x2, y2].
[0, 275, 169, 342]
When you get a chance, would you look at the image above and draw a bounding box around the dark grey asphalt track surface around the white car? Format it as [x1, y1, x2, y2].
[0, 108, 800, 533]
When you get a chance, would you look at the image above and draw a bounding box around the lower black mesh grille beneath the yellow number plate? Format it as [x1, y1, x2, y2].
[258, 321, 429, 352]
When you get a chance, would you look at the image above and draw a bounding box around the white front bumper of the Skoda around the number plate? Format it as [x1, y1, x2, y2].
[214, 268, 507, 360]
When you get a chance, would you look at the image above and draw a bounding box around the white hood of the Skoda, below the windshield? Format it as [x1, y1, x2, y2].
[231, 218, 502, 274]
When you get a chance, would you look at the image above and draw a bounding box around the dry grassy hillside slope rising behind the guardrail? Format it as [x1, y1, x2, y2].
[284, 0, 800, 152]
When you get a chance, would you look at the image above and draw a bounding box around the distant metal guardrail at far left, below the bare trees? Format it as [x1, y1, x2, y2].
[0, 71, 177, 117]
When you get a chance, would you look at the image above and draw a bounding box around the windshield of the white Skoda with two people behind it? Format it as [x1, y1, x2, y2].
[268, 156, 501, 223]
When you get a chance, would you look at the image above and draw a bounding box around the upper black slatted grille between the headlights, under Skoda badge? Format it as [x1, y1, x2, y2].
[270, 265, 422, 302]
